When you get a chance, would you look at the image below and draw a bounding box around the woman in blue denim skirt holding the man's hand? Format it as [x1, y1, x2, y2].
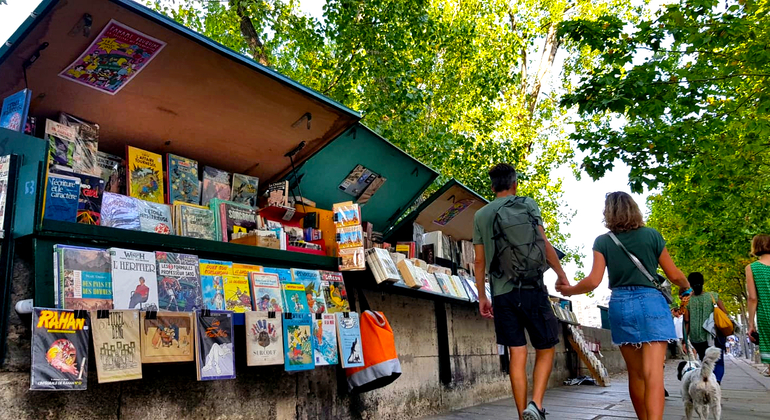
[556, 192, 690, 420]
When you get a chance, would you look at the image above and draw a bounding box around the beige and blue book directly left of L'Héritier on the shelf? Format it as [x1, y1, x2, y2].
[54, 245, 113, 311]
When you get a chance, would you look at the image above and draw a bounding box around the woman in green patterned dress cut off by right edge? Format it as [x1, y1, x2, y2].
[746, 235, 770, 364]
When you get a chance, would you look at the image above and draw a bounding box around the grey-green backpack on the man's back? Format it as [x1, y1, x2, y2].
[490, 197, 548, 288]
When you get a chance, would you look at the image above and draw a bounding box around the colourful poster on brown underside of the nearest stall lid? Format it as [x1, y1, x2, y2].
[59, 20, 166, 95]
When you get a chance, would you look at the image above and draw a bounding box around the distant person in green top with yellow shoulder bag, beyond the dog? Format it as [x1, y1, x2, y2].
[684, 271, 727, 384]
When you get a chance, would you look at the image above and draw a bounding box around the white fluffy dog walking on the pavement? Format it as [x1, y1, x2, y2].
[682, 347, 722, 420]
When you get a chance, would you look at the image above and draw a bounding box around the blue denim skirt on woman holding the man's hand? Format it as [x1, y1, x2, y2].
[609, 286, 676, 346]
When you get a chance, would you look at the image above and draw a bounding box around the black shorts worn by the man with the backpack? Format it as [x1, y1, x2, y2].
[492, 289, 559, 350]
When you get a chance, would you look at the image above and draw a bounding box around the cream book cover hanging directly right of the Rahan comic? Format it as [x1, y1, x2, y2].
[91, 311, 142, 384]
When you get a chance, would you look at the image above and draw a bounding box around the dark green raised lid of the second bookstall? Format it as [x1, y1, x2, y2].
[292, 123, 438, 232]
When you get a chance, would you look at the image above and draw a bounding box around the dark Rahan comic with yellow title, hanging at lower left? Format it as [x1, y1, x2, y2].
[29, 308, 90, 390]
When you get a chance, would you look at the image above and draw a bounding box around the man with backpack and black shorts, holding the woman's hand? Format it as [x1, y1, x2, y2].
[473, 163, 569, 420]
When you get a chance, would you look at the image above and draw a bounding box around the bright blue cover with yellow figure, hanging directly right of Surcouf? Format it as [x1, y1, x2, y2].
[283, 314, 315, 372]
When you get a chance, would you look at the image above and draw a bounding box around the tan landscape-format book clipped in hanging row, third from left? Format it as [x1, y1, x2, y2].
[139, 312, 195, 363]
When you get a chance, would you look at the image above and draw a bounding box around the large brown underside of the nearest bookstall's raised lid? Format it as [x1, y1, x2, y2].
[0, 0, 361, 185]
